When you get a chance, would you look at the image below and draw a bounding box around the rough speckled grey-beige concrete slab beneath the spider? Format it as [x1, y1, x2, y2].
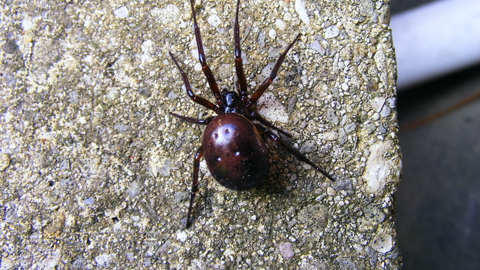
[0, 0, 401, 269]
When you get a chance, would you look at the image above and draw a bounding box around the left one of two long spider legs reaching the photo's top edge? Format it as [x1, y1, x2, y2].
[190, 0, 222, 106]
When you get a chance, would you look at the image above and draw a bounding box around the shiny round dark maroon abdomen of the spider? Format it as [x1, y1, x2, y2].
[203, 113, 270, 190]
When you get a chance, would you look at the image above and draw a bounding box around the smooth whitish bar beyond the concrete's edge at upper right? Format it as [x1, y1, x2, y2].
[391, 0, 480, 89]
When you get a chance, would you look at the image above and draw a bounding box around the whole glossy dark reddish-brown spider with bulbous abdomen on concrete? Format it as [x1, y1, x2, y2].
[169, 0, 334, 228]
